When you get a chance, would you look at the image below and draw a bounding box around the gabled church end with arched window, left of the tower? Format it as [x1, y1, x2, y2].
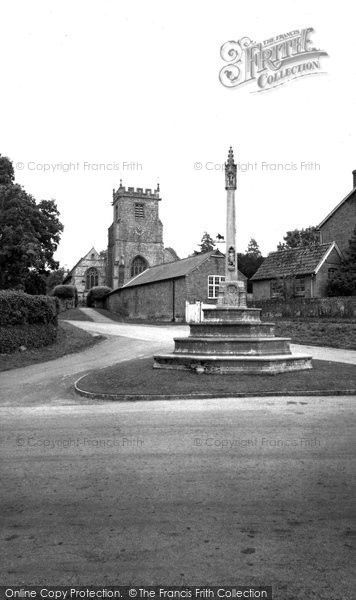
[63, 248, 106, 303]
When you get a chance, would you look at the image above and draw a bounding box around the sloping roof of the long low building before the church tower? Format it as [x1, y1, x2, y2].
[119, 250, 246, 289]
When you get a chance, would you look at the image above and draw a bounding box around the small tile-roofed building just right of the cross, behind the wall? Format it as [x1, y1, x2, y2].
[251, 242, 342, 300]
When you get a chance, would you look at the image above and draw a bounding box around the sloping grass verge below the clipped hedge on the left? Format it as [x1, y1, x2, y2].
[0, 323, 105, 371]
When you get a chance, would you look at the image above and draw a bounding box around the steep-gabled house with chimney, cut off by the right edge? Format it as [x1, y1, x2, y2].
[317, 170, 356, 253]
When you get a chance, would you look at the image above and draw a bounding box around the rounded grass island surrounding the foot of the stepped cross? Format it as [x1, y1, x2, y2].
[74, 358, 356, 398]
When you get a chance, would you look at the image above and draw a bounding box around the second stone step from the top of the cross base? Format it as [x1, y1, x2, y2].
[190, 321, 274, 337]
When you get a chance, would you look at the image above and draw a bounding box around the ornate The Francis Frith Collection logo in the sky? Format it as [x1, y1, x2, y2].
[219, 27, 328, 92]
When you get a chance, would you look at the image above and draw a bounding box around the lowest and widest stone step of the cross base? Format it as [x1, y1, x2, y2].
[153, 354, 312, 375]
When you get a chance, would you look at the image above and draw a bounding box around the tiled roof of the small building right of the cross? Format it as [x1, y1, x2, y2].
[251, 243, 333, 281]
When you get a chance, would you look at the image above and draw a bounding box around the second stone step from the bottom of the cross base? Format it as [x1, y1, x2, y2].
[174, 336, 290, 356]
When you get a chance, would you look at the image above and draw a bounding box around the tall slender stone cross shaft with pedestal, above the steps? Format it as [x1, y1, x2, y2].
[218, 146, 246, 308]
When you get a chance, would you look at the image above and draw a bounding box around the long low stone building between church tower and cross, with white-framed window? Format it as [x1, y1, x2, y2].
[106, 250, 246, 320]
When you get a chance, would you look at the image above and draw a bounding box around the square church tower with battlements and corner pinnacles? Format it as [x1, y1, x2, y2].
[108, 181, 165, 289]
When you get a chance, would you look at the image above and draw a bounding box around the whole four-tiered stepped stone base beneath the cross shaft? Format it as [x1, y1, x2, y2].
[153, 305, 312, 375]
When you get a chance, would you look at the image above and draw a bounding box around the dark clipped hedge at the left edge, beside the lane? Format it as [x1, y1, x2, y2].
[0, 290, 59, 354]
